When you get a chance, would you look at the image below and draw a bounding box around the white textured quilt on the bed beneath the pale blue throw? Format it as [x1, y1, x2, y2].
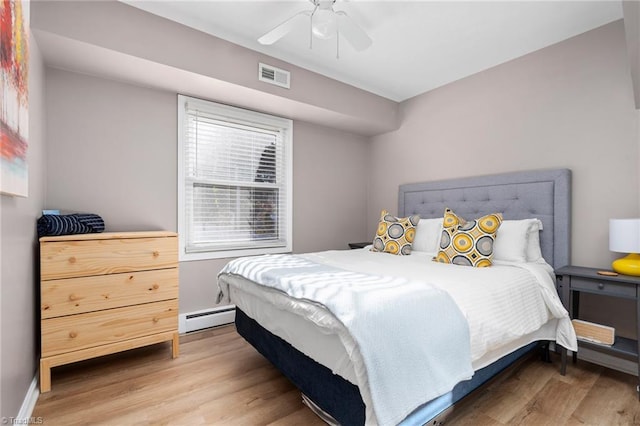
[218, 249, 577, 426]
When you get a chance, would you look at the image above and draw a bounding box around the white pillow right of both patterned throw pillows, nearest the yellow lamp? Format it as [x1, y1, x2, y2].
[493, 219, 542, 262]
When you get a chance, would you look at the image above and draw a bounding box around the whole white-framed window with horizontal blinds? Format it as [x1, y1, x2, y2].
[178, 95, 293, 260]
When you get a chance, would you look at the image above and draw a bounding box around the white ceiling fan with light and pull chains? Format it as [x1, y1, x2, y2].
[258, 0, 372, 56]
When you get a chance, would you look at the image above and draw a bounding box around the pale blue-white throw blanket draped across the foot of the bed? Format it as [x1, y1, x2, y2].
[220, 255, 473, 425]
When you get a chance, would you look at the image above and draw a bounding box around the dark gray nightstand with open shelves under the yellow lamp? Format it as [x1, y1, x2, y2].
[555, 266, 640, 396]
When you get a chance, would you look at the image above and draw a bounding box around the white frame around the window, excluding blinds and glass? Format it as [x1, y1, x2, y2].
[177, 94, 293, 261]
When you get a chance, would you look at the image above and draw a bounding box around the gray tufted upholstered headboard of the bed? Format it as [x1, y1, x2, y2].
[398, 169, 571, 268]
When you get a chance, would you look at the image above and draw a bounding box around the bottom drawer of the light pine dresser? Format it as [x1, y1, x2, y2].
[41, 300, 178, 357]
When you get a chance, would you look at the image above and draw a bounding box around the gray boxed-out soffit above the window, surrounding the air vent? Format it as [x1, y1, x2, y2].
[32, 0, 398, 135]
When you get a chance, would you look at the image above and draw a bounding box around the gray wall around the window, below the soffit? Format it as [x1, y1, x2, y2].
[46, 68, 368, 313]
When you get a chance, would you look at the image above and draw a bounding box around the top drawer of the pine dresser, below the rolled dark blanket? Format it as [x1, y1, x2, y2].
[40, 237, 178, 281]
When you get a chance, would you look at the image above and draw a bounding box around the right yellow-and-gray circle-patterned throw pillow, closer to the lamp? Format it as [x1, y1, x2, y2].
[433, 209, 502, 268]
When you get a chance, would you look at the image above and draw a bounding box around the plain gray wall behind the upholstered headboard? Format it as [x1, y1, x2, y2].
[367, 21, 639, 268]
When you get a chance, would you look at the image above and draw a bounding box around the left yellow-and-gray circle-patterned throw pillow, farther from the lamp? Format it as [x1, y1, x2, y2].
[371, 210, 420, 256]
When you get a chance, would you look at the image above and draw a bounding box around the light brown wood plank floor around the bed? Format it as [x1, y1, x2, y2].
[33, 326, 640, 426]
